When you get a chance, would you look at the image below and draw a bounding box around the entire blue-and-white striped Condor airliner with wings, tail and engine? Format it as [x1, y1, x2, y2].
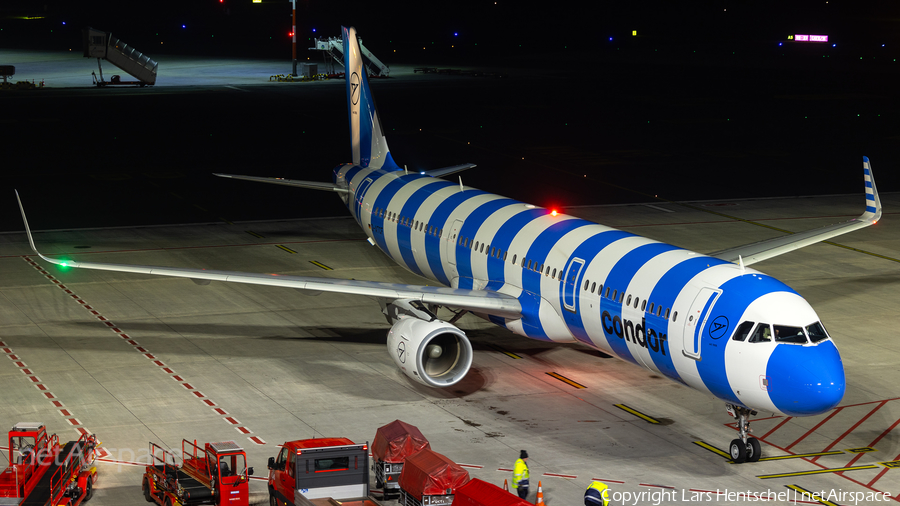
[19, 28, 882, 462]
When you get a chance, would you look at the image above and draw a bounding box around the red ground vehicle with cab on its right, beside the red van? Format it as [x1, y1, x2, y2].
[141, 439, 253, 506]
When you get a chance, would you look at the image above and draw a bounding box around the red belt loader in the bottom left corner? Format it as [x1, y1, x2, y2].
[0, 422, 98, 506]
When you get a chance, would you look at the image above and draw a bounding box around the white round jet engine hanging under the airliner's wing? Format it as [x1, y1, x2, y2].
[387, 316, 472, 387]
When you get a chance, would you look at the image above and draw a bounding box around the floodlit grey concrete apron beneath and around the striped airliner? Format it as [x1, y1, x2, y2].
[0, 192, 900, 506]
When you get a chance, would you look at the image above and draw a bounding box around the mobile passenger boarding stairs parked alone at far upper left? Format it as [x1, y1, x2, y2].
[83, 27, 159, 86]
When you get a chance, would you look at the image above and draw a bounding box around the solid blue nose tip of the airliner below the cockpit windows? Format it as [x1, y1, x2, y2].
[766, 340, 847, 416]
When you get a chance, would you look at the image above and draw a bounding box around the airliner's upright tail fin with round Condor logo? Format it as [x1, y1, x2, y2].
[342, 27, 400, 170]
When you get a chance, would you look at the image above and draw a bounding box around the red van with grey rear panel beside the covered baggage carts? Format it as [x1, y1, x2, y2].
[269, 437, 369, 506]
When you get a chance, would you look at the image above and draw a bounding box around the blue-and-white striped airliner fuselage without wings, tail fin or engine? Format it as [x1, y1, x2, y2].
[334, 164, 845, 416]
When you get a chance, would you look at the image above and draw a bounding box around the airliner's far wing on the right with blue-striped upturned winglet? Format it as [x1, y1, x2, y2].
[710, 157, 881, 265]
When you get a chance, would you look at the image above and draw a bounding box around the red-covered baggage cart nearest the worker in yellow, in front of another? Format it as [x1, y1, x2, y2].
[399, 450, 469, 506]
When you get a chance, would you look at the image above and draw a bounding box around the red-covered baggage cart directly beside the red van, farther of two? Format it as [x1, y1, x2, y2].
[372, 420, 431, 498]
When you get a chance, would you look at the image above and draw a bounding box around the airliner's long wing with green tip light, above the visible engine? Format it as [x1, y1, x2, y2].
[16, 192, 522, 319]
